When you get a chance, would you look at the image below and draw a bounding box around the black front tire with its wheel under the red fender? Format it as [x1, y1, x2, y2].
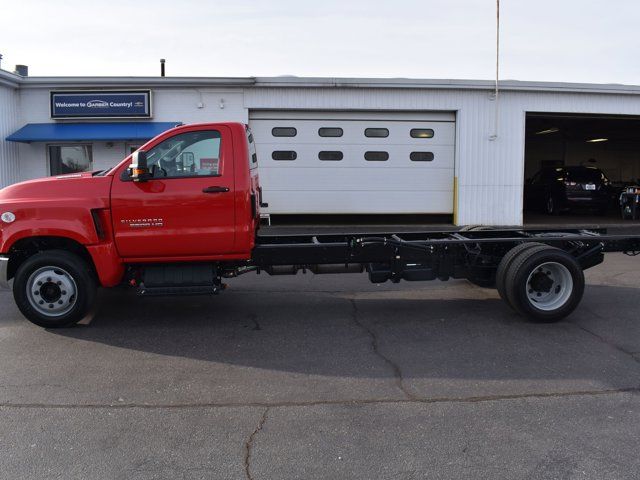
[13, 250, 97, 328]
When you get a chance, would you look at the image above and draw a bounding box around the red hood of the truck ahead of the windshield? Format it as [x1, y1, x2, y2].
[0, 172, 113, 208]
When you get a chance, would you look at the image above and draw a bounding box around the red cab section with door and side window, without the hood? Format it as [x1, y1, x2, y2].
[107, 123, 259, 263]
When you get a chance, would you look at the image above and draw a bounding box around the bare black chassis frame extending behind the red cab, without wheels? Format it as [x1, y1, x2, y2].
[253, 229, 640, 267]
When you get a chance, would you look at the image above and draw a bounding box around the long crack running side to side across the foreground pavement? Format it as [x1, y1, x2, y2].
[0, 385, 640, 410]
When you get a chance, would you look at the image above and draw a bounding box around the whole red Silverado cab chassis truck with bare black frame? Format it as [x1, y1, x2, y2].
[0, 122, 640, 328]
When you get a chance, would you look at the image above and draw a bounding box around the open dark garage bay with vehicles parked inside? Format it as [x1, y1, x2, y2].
[523, 113, 640, 226]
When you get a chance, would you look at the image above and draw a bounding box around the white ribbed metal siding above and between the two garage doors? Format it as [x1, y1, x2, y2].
[245, 87, 640, 225]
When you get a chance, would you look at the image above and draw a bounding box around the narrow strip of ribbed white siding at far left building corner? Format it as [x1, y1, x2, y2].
[0, 85, 20, 188]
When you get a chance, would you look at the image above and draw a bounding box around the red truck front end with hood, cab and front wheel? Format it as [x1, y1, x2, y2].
[0, 123, 260, 326]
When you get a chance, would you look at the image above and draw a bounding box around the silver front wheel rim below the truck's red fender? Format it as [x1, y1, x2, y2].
[26, 266, 78, 317]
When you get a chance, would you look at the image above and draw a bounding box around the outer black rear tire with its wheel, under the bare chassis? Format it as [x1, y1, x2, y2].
[505, 245, 584, 323]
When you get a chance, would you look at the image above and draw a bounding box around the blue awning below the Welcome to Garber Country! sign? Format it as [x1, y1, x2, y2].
[7, 122, 180, 143]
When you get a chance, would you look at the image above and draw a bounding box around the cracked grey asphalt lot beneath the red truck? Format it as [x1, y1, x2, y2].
[0, 254, 640, 480]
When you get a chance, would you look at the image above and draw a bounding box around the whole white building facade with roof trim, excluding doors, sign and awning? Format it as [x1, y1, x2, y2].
[7, 78, 640, 225]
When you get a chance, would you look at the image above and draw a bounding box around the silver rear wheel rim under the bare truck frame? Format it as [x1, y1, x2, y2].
[525, 262, 573, 311]
